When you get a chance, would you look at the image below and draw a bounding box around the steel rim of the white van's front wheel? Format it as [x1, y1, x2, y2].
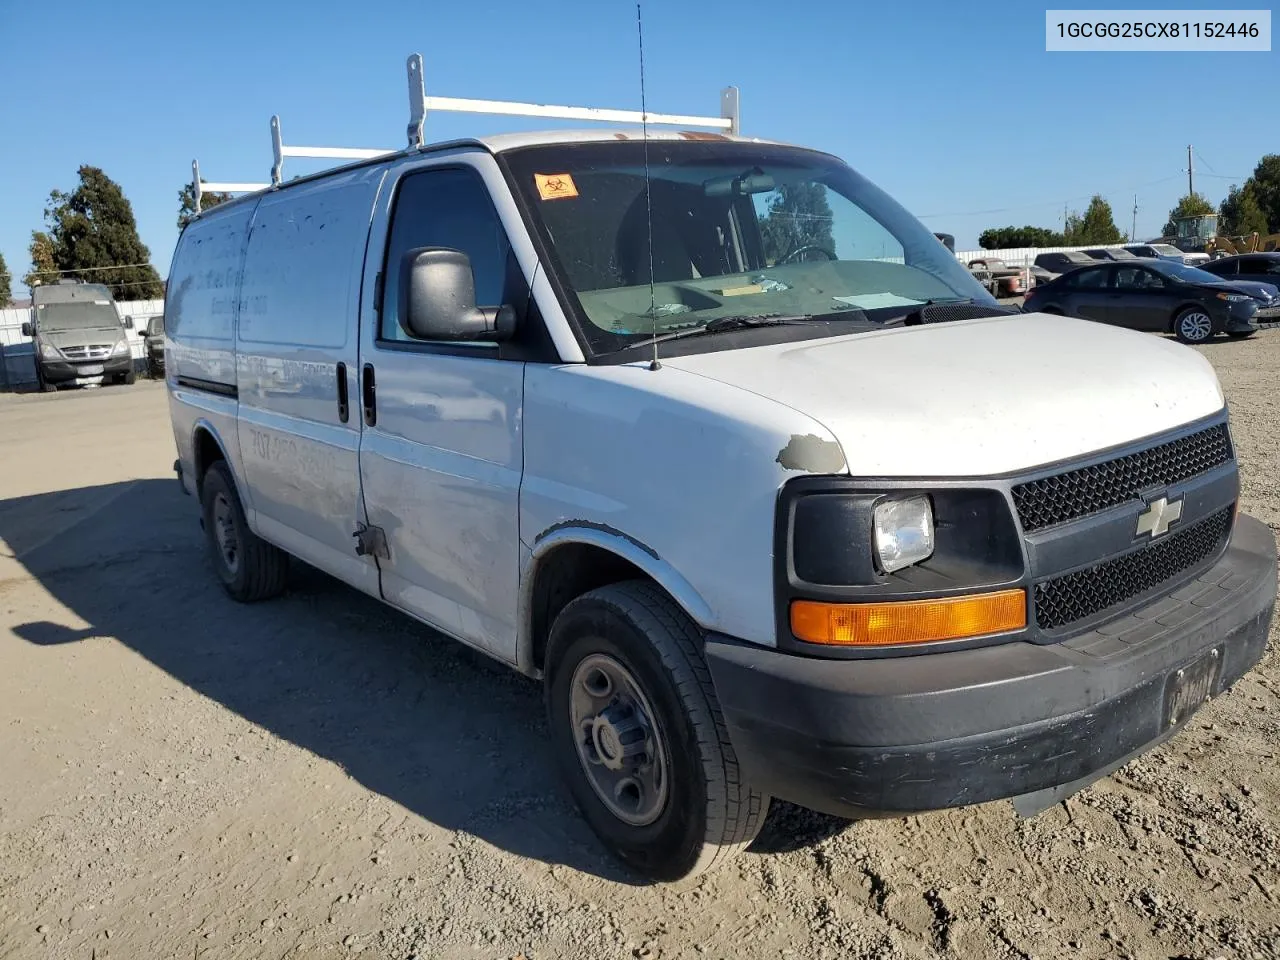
[568, 654, 671, 827]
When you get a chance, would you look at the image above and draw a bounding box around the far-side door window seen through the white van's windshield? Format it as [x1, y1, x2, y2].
[751, 180, 905, 266]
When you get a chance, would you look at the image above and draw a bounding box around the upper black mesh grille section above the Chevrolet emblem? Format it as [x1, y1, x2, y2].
[1014, 424, 1231, 531]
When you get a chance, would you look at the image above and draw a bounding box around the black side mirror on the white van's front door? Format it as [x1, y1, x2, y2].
[399, 247, 516, 340]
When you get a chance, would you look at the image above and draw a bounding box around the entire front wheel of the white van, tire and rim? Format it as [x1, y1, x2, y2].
[547, 581, 769, 881]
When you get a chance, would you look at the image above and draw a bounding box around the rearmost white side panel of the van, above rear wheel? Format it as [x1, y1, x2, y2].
[165, 202, 255, 506]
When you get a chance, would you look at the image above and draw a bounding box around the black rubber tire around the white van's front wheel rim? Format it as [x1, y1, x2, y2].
[545, 580, 769, 881]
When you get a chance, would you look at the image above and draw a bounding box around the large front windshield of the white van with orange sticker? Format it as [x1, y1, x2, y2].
[502, 140, 993, 353]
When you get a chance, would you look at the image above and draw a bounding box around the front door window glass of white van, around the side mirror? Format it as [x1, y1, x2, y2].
[378, 168, 511, 346]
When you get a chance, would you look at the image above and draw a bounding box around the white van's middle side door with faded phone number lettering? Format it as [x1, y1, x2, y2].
[236, 166, 385, 595]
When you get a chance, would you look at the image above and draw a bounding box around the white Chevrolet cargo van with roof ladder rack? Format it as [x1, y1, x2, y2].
[165, 60, 1276, 878]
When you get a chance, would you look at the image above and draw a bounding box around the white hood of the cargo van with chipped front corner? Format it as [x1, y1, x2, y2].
[662, 314, 1224, 477]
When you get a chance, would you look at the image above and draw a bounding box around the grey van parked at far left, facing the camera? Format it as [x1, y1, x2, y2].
[22, 280, 134, 392]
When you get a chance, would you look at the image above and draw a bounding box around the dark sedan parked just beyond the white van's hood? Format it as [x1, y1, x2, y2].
[1023, 260, 1260, 343]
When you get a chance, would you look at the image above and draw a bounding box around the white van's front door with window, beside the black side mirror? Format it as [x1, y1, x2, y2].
[360, 160, 527, 662]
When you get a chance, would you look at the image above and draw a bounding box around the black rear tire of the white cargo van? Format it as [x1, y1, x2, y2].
[200, 460, 289, 603]
